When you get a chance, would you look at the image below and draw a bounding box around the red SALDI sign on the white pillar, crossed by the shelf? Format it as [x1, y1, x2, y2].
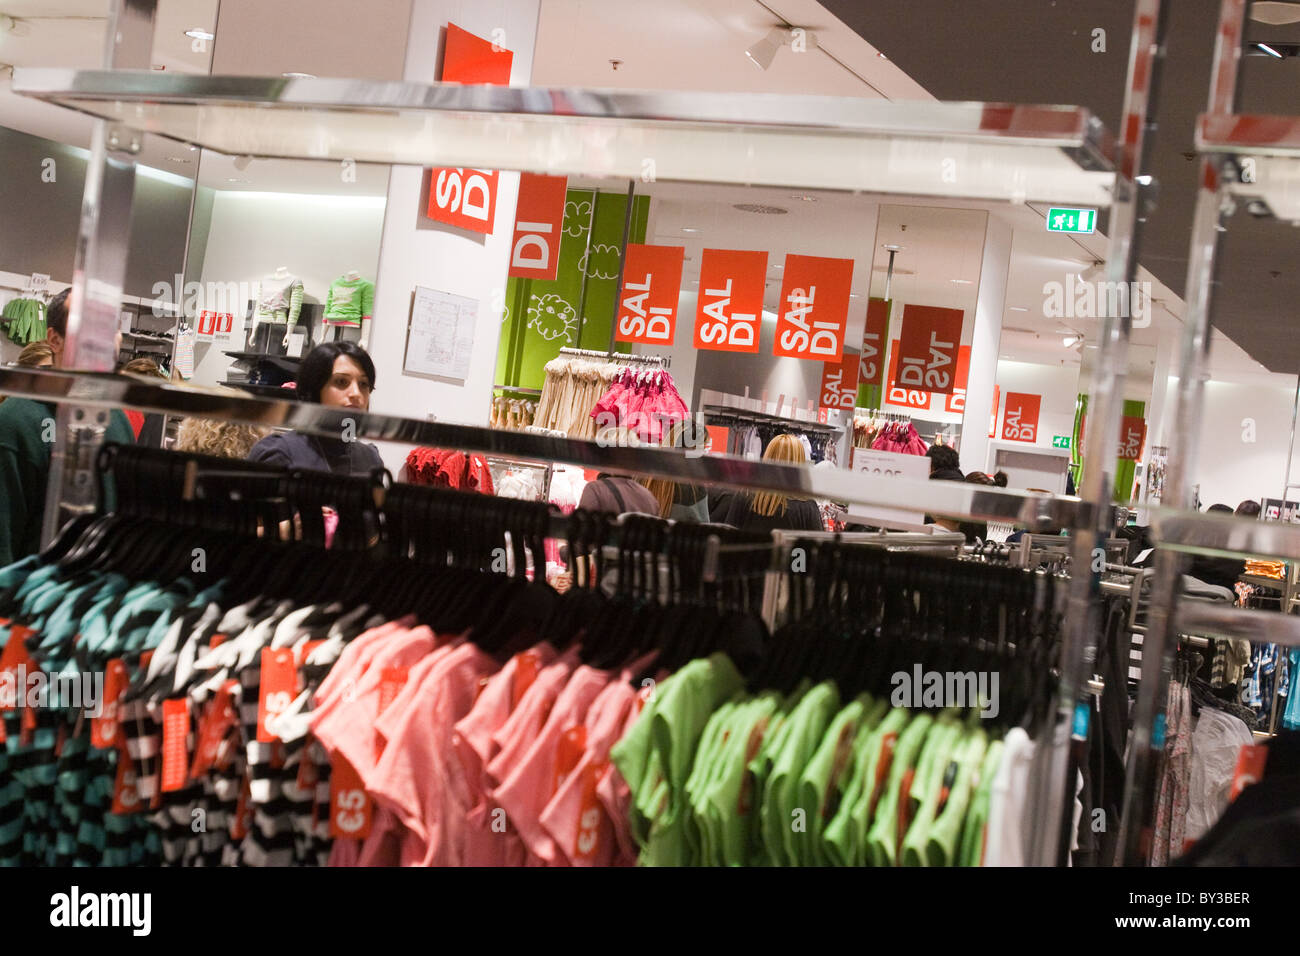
[428, 23, 515, 234]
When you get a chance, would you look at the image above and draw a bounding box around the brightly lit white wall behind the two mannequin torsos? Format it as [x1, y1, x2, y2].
[194, 191, 384, 385]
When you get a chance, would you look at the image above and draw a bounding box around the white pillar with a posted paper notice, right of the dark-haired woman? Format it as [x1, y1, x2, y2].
[371, 0, 540, 473]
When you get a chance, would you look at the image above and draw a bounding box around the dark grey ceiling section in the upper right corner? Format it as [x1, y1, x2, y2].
[824, 0, 1300, 373]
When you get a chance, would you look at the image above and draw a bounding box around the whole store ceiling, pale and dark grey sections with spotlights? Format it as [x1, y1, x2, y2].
[0, 0, 1300, 390]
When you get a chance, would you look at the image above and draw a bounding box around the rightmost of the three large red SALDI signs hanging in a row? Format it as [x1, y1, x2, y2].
[772, 255, 853, 362]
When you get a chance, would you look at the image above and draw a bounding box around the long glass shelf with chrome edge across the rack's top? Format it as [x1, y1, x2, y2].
[13, 69, 1115, 207]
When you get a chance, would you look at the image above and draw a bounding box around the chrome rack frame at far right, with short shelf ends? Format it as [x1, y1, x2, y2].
[1119, 0, 1300, 865]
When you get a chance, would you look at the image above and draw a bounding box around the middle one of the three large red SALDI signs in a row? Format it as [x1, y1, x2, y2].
[694, 248, 767, 352]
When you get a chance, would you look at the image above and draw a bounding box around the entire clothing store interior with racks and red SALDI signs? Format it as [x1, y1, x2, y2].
[0, 0, 1300, 868]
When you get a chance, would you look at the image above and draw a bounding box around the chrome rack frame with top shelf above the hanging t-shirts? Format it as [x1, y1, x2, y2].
[0, 0, 1165, 864]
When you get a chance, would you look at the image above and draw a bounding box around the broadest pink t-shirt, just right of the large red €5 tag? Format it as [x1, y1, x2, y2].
[367, 643, 498, 866]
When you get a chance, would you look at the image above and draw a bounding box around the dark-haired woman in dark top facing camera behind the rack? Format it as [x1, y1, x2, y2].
[248, 342, 384, 475]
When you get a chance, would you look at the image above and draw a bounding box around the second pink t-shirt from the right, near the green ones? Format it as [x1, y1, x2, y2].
[493, 665, 611, 866]
